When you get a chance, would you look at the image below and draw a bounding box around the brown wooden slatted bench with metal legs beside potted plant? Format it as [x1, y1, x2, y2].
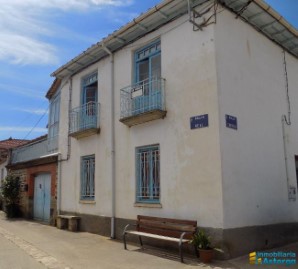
[123, 215, 197, 262]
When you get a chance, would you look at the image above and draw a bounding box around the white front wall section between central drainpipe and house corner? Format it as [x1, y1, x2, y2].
[115, 16, 222, 227]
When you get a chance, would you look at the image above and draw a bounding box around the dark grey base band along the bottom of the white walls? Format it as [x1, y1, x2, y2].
[61, 212, 298, 259]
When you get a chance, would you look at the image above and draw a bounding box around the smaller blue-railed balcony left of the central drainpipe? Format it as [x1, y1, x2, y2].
[69, 102, 100, 139]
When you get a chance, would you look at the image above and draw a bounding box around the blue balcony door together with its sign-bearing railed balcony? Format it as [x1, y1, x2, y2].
[120, 40, 166, 126]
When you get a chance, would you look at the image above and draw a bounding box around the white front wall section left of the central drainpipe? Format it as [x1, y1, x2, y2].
[59, 58, 111, 216]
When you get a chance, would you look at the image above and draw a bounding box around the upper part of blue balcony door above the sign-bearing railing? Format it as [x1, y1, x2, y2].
[135, 40, 161, 82]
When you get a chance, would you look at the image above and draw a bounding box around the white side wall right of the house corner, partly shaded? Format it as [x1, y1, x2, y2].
[215, 7, 298, 228]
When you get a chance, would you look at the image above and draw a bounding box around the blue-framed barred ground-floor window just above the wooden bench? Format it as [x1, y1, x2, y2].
[136, 145, 160, 203]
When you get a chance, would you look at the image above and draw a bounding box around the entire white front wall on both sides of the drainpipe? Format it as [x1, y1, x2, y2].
[59, 10, 223, 228]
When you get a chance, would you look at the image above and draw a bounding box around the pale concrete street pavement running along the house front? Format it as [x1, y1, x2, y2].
[0, 212, 298, 269]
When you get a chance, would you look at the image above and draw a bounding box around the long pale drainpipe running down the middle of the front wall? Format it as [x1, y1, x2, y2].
[102, 45, 116, 239]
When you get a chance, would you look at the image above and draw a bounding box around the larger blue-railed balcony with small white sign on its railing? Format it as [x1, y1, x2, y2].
[120, 78, 167, 127]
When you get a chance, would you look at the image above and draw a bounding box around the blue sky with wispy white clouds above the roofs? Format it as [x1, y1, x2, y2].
[0, 0, 298, 140]
